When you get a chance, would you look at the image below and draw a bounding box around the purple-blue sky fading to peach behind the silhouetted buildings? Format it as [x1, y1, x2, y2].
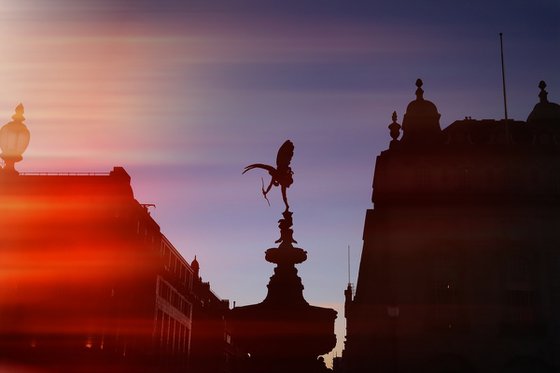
[0, 0, 560, 355]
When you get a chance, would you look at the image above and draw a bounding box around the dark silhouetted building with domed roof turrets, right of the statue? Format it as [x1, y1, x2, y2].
[343, 81, 560, 373]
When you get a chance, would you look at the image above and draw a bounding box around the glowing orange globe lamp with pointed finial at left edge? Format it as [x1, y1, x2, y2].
[0, 104, 30, 175]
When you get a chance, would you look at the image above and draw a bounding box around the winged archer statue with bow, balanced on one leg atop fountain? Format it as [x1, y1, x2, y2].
[243, 140, 294, 211]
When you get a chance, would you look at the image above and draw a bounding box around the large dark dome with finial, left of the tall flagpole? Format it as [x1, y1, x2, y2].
[402, 79, 442, 145]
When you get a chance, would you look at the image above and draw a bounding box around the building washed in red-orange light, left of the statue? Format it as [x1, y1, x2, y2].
[0, 167, 233, 372]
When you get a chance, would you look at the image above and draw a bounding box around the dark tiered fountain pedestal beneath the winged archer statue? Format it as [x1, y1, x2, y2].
[231, 211, 336, 373]
